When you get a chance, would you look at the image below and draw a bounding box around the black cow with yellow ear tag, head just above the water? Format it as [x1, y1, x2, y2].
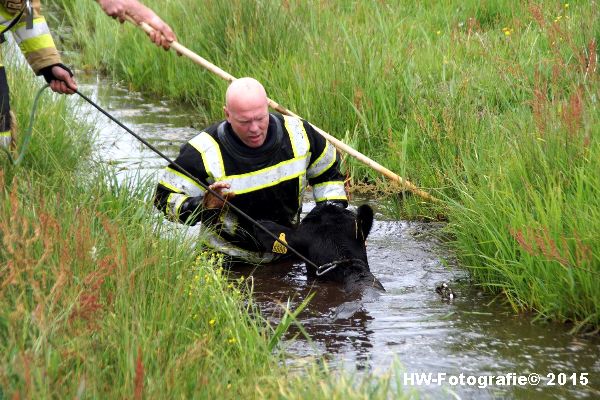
[255, 203, 384, 292]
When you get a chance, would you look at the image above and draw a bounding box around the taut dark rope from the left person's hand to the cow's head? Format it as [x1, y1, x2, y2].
[75, 90, 319, 269]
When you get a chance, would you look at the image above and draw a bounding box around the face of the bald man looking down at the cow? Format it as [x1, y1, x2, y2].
[225, 101, 269, 148]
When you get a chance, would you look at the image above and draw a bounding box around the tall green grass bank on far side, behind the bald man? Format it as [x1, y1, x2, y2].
[57, 0, 600, 328]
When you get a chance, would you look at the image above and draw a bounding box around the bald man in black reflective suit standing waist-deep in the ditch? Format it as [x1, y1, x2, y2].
[154, 78, 348, 263]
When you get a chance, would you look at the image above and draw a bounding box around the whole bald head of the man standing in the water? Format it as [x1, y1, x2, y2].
[223, 78, 269, 148]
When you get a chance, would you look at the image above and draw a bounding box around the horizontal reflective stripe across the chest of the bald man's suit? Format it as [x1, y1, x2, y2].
[225, 156, 307, 194]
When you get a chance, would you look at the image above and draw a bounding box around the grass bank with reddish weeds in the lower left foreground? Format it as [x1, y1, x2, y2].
[0, 56, 404, 399]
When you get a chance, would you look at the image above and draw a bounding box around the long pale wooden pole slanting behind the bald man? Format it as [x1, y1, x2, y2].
[128, 18, 440, 203]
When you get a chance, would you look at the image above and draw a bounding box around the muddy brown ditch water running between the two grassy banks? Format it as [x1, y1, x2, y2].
[80, 77, 600, 399]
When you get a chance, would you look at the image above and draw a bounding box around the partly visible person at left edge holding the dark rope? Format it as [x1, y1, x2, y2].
[0, 0, 77, 148]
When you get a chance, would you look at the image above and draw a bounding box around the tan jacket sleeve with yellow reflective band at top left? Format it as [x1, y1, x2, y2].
[0, 0, 61, 75]
